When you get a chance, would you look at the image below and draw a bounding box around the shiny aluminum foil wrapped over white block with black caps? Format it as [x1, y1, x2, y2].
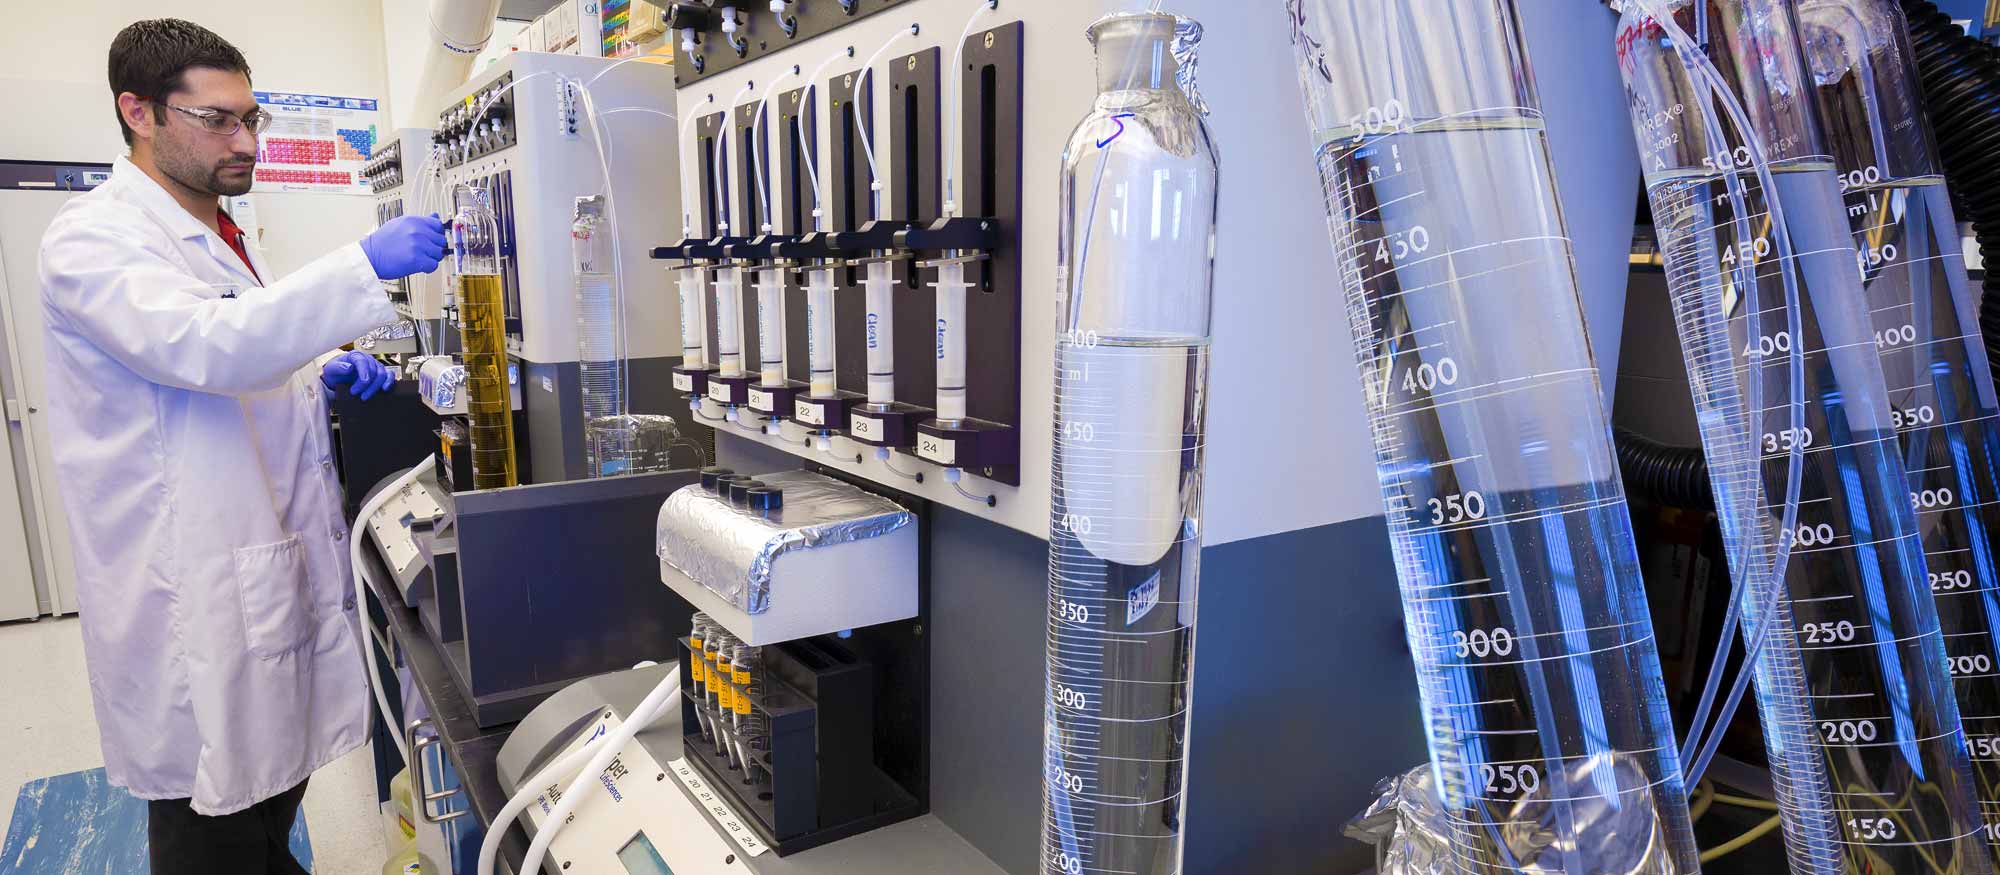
[654, 471, 916, 613]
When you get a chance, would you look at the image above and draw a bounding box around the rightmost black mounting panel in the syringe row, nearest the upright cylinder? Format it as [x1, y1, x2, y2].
[956, 22, 1026, 485]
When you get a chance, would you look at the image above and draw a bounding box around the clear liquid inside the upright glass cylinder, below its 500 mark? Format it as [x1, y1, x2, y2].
[1044, 334, 1208, 875]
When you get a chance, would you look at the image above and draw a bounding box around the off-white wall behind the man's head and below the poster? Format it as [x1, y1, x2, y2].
[0, 0, 390, 274]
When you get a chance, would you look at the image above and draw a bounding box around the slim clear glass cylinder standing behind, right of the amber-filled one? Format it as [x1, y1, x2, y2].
[570, 196, 632, 477]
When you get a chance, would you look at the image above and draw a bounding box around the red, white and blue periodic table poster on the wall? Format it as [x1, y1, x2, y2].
[252, 92, 380, 196]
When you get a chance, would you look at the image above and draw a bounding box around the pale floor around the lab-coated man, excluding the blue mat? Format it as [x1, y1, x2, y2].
[0, 617, 386, 875]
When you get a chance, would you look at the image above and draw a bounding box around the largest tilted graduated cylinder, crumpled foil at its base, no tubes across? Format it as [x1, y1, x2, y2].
[1290, 0, 1698, 875]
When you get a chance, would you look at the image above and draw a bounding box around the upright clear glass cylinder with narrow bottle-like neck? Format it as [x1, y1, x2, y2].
[1048, 14, 1230, 875]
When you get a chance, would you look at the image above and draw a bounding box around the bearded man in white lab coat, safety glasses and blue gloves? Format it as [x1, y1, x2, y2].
[40, 20, 444, 875]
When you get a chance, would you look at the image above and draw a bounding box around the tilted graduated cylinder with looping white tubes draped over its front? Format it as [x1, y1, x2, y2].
[1618, 0, 1990, 875]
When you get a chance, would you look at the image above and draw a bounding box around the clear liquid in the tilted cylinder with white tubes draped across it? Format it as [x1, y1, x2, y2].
[1648, 160, 1988, 875]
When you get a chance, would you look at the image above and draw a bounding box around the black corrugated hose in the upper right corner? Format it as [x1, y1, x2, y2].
[1902, 0, 2000, 380]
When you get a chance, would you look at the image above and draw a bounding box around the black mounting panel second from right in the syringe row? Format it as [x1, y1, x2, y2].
[882, 48, 944, 417]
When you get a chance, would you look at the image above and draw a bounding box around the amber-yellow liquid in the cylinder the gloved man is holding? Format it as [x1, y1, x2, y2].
[458, 274, 520, 489]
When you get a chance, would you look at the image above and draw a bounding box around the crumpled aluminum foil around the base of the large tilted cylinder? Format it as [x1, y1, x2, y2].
[1346, 753, 1680, 875]
